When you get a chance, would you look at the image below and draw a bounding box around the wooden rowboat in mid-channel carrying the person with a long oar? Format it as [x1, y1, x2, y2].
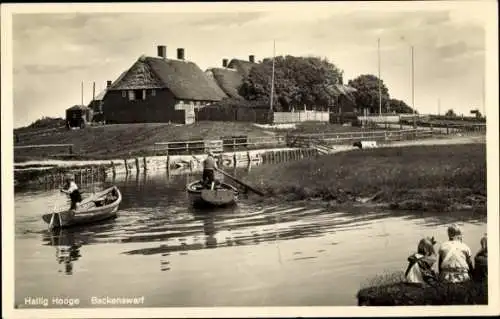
[187, 180, 238, 207]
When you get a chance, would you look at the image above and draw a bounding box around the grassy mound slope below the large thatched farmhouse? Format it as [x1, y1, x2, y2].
[15, 122, 278, 161]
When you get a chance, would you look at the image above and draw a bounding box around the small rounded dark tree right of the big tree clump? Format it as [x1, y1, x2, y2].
[348, 74, 389, 113]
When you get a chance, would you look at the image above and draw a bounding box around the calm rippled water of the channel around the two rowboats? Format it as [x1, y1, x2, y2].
[15, 170, 486, 308]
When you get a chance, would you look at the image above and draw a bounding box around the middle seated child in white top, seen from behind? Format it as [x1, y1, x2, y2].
[438, 225, 473, 283]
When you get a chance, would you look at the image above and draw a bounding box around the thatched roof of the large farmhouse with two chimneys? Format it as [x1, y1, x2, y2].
[109, 56, 226, 101]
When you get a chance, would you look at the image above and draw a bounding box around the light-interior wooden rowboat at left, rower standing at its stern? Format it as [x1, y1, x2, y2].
[42, 186, 122, 229]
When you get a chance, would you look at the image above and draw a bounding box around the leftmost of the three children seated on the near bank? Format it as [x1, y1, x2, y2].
[405, 237, 437, 285]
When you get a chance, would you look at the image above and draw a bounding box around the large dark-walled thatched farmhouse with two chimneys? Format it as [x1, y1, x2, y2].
[103, 46, 227, 124]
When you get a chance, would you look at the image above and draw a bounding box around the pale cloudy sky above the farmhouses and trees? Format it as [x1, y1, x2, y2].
[4, 1, 496, 127]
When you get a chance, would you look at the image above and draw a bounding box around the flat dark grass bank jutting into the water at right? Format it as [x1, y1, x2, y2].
[247, 144, 486, 211]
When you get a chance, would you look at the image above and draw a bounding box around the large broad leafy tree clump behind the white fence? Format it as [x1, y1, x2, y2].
[240, 55, 342, 111]
